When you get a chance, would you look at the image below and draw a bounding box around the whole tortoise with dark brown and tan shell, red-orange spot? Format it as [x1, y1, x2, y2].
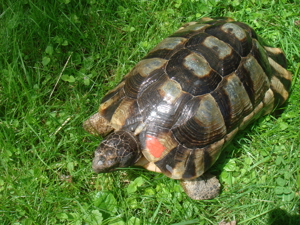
[83, 17, 292, 200]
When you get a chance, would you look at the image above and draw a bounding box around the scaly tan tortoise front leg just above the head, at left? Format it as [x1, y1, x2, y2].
[83, 113, 114, 136]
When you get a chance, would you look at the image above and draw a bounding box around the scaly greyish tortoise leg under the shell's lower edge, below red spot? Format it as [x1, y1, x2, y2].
[181, 173, 221, 200]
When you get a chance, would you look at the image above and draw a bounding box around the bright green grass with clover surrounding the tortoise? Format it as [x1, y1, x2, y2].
[0, 0, 300, 225]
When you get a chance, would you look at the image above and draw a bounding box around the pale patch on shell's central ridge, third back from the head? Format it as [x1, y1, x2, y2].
[203, 36, 232, 60]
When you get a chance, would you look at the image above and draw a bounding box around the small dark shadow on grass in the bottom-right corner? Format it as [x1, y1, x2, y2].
[268, 205, 300, 225]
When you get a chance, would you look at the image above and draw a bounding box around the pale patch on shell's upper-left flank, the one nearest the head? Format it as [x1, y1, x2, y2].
[130, 58, 168, 77]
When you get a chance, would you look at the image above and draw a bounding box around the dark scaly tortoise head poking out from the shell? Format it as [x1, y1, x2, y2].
[93, 130, 142, 173]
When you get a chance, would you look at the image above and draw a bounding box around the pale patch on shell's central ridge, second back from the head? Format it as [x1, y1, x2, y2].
[183, 53, 212, 78]
